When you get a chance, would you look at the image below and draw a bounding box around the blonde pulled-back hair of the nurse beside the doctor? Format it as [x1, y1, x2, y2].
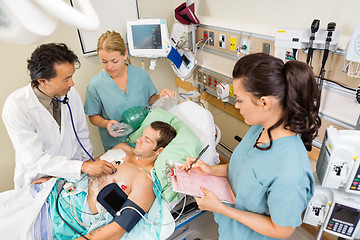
[96, 31, 131, 64]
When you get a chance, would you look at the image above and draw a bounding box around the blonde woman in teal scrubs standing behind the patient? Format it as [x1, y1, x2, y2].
[85, 31, 176, 151]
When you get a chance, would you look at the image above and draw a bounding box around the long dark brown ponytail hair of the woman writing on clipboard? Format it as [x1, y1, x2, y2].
[233, 53, 321, 151]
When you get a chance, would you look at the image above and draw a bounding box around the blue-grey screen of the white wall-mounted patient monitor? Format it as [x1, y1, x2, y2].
[131, 24, 162, 49]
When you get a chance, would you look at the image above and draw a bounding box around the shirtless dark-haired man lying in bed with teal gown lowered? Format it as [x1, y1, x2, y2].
[33, 121, 176, 239]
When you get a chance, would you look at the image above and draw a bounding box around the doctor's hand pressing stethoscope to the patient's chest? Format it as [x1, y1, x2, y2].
[81, 159, 116, 177]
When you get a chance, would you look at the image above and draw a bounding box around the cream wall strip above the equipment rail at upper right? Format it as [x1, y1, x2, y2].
[196, 0, 360, 35]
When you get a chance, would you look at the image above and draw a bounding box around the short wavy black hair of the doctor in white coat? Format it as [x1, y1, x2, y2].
[27, 43, 80, 87]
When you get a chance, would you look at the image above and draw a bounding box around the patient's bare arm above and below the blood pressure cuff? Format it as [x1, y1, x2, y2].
[78, 172, 155, 240]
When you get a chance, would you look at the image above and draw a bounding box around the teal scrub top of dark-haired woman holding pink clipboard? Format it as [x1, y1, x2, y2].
[214, 125, 314, 240]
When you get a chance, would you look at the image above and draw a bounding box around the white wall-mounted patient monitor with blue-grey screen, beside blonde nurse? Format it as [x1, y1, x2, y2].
[126, 19, 171, 58]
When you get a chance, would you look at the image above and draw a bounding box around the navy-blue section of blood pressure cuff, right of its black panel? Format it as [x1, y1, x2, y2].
[114, 199, 145, 232]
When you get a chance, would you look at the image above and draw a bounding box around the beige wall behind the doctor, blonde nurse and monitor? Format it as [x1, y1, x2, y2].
[0, 0, 180, 192]
